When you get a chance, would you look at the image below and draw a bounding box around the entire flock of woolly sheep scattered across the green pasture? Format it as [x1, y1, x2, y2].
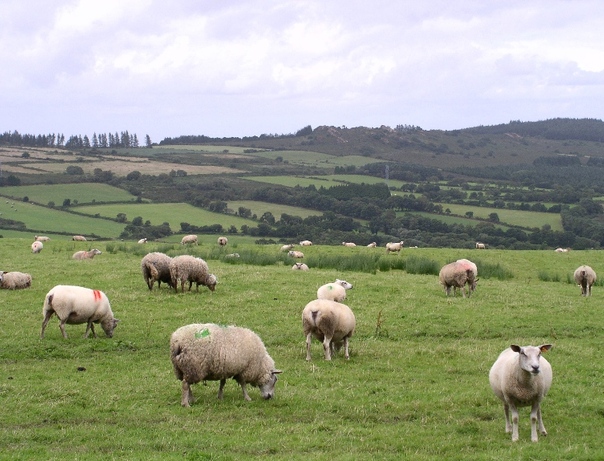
[0, 235, 596, 442]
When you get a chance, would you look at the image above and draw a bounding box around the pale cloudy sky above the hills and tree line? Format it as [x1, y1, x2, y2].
[0, 0, 604, 142]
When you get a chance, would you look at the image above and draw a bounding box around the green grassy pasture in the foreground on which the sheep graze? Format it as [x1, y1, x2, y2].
[0, 239, 604, 461]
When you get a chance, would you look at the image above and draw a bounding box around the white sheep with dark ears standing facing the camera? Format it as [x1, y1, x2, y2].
[489, 344, 552, 442]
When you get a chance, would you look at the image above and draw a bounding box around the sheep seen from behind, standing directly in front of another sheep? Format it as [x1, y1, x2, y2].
[302, 299, 356, 360]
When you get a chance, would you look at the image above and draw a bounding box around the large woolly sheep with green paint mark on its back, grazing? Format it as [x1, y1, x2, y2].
[170, 323, 281, 407]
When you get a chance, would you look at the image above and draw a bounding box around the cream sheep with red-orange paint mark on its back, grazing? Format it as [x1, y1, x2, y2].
[40, 285, 119, 339]
